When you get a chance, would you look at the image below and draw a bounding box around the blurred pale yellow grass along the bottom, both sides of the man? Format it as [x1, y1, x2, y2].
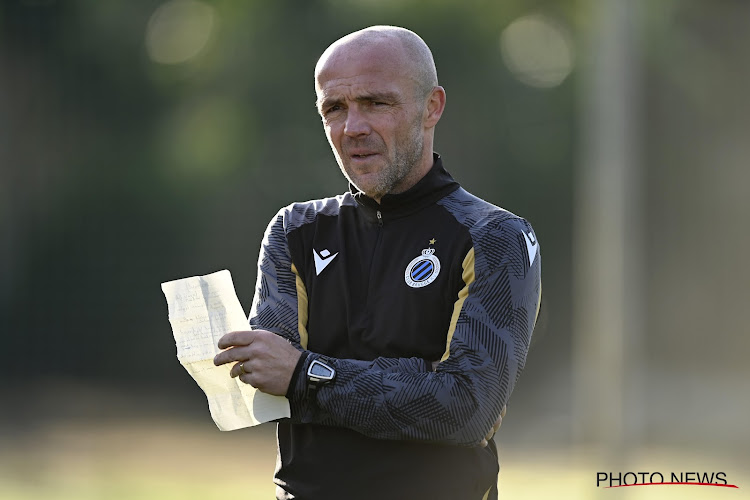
[0, 419, 750, 500]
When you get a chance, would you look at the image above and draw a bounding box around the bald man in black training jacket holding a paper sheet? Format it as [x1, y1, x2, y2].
[215, 26, 541, 500]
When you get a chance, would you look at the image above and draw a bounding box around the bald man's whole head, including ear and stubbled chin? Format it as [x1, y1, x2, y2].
[315, 26, 445, 201]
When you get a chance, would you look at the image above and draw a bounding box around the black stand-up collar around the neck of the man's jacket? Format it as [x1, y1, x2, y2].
[349, 153, 461, 222]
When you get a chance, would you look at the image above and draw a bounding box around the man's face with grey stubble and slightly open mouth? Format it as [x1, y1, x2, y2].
[316, 43, 425, 201]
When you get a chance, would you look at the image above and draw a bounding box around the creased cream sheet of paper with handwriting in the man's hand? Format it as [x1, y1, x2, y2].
[161, 270, 290, 431]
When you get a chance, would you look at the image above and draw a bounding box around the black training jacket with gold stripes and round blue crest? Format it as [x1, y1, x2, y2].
[250, 155, 541, 500]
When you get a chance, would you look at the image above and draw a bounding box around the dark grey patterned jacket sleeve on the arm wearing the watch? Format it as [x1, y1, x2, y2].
[290, 214, 541, 446]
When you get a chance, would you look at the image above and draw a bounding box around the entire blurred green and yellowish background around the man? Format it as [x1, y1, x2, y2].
[0, 0, 750, 499]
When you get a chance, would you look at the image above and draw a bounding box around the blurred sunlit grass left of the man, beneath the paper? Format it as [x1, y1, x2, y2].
[0, 421, 276, 500]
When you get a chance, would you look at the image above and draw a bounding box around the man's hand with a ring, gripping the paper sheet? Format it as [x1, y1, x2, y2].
[214, 330, 302, 396]
